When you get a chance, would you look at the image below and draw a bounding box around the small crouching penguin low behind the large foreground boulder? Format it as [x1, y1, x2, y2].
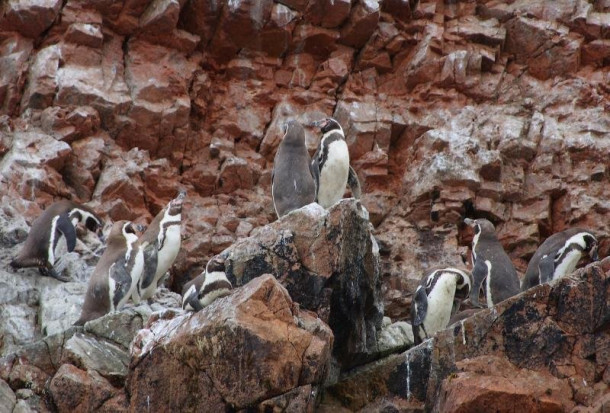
[182, 255, 233, 311]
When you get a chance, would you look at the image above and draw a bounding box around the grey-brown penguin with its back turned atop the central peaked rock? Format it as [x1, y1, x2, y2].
[271, 121, 317, 218]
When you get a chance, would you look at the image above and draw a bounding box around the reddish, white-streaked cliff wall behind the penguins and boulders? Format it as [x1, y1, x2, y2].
[0, 0, 610, 408]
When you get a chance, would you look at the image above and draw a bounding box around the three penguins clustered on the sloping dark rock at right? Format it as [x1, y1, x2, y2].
[411, 218, 598, 344]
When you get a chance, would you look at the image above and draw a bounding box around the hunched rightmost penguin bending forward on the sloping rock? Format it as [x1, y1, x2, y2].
[521, 228, 598, 291]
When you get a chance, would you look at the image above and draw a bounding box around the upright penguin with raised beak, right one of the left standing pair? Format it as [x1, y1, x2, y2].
[133, 190, 186, 304]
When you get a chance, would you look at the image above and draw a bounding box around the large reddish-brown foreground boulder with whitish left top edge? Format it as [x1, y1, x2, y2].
[129, 275, 332, 409]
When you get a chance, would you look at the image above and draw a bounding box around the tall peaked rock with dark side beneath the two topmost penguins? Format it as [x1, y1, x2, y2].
[223, 200, 382, 368]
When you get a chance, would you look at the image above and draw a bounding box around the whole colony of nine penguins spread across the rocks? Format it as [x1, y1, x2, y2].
[10, 118, 598, 343]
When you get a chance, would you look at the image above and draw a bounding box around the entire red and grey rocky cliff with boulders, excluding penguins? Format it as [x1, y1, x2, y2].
[0, 0, 610, 411]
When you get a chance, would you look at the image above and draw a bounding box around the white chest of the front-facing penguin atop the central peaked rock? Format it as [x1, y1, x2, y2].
[318, 139, 349, 208]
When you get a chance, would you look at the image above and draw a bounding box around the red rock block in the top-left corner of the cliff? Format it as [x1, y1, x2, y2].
[0, 0, 62, 39]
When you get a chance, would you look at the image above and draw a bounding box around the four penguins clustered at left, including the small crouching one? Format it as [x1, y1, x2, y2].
[10, 190, 231, 325]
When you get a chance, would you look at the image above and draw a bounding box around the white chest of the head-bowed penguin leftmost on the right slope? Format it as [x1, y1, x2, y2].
[424, 275, 456, 336]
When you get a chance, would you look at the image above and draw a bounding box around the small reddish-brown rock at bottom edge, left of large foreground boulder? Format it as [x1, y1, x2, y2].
[49, 364, 117, 412]
